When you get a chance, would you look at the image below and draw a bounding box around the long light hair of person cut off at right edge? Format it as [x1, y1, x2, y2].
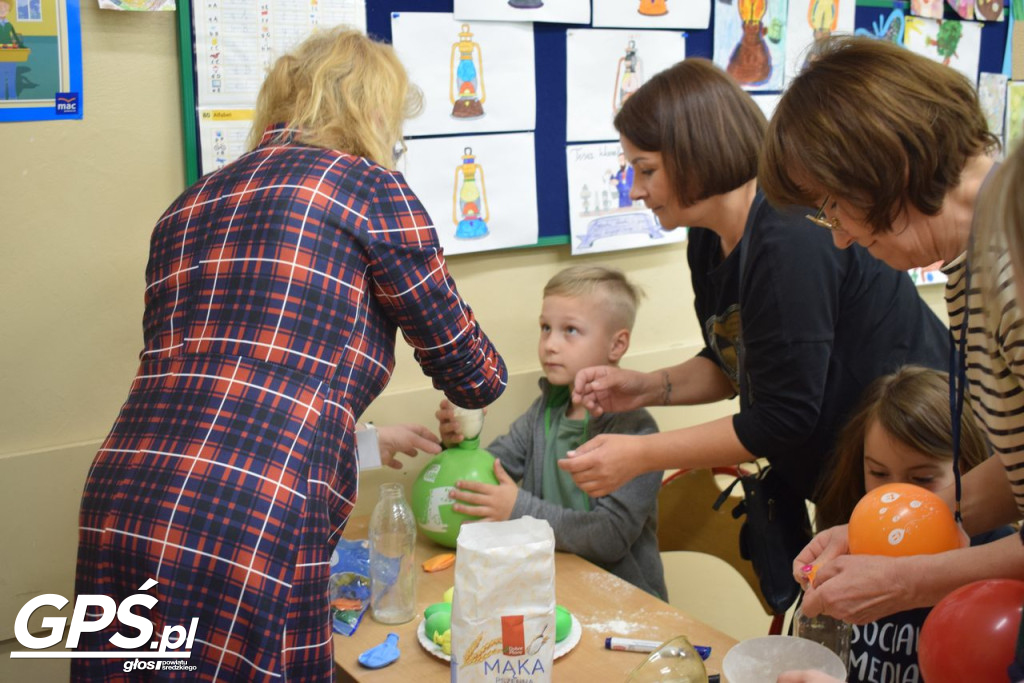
[970, 143, 1024, 321]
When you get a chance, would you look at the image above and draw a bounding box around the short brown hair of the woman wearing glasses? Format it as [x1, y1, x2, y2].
[758, 36, 998, 232]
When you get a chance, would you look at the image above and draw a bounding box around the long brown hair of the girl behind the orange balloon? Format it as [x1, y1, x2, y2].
[816, 366, 988, 529]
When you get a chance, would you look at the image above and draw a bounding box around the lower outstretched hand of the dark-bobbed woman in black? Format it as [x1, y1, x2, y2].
[558, 434, 644, 498]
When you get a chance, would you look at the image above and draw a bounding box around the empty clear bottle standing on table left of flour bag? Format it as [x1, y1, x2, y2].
[370, 483, 416, 624]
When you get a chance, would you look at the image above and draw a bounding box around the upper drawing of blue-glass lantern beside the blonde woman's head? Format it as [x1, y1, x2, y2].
[391, 12, 537, 136]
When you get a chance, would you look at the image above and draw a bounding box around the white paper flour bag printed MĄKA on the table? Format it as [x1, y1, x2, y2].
[452, 517, 555, 683]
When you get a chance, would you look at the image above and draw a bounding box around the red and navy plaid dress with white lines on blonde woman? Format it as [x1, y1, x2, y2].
[72, 128, 506, 683]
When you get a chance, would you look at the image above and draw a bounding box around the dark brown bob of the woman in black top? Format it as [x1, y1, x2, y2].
[614, 57, 765, 206]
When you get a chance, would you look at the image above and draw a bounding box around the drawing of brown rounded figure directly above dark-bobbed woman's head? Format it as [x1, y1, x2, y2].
[715, 0, 787, 90]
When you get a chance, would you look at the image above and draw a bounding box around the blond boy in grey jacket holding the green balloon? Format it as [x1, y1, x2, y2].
[437, 266, 667, 600]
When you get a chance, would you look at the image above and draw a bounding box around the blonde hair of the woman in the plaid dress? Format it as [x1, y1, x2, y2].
[249, 27, 422, 168]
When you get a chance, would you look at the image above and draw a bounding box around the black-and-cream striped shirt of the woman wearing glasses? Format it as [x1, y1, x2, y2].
[942, 253, 1024, 514]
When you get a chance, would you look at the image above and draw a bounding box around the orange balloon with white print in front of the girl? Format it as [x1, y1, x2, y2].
[849, 483, 961, 557]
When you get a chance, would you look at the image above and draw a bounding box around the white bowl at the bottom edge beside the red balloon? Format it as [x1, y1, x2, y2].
[722, 636, 846, 683]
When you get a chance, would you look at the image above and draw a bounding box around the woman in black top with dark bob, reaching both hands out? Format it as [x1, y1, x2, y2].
[559, 58, 948, 565]
